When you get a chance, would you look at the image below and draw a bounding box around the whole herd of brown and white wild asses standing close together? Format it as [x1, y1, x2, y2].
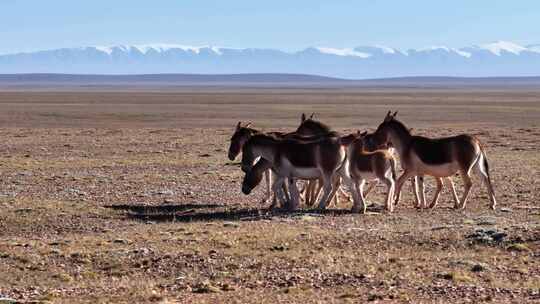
[229, 112, 496, 213]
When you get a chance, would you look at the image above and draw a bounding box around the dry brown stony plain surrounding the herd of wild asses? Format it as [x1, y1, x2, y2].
[0, 86, 540, 303]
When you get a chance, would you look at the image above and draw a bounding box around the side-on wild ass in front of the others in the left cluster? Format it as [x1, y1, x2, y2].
[242, 133, 356, 210]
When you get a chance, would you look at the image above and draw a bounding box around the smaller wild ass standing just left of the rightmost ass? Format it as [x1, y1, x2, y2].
[347, 131, 396, 212]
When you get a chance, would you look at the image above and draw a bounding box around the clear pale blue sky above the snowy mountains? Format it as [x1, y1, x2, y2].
[0, 0, 540, 53]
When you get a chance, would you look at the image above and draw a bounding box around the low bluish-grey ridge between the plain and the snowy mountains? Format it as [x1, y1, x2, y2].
[0, 73, 540, 89]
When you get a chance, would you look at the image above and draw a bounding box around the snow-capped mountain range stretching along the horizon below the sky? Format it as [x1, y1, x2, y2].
[0, 41, 540, 79]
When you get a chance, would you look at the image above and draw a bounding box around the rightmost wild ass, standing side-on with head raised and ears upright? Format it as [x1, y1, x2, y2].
[375, 112, 497, 209]
